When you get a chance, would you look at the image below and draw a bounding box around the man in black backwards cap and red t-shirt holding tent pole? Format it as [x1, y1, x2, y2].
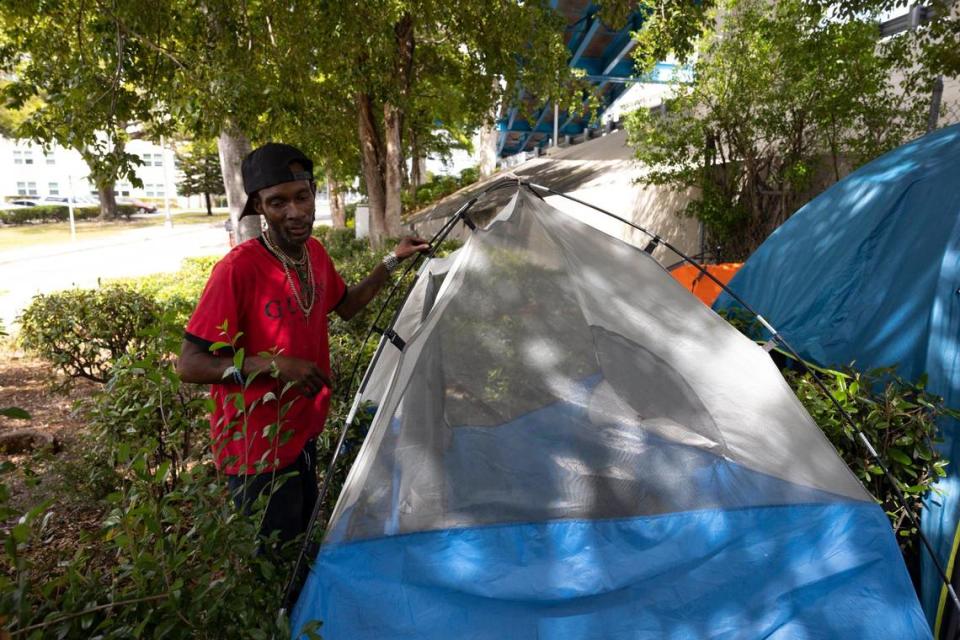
[177, 143, 429, 542]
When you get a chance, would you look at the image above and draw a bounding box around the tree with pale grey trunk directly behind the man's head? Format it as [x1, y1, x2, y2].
[109, 0, 368, 241]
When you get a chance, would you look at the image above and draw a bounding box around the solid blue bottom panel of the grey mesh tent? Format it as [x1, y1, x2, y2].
[292, 502, 930, 640]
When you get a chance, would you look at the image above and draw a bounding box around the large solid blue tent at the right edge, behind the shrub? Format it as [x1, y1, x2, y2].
[715, 125, 960, 622]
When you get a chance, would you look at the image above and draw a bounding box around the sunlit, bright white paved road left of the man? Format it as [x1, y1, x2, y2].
[0, 223, 229, 329]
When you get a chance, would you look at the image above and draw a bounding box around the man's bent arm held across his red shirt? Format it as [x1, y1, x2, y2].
[177, 340, 333, 396]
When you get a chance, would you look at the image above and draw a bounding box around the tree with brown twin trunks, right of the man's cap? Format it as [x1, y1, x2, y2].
[325, 0, 570, 242]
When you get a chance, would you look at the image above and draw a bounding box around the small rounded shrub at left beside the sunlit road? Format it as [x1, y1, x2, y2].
[20, 286, 160, 382]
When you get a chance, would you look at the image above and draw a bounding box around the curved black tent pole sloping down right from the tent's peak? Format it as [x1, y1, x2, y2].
[521, 181, 960, 612]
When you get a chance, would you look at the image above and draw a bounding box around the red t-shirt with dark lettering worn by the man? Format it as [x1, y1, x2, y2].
[186, 238, 346, 474]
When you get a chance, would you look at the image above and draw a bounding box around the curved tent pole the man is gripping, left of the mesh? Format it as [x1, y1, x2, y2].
[279, 176, 521, 616]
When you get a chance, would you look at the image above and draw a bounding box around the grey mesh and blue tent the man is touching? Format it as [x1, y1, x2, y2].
[291, 190, 930, 640]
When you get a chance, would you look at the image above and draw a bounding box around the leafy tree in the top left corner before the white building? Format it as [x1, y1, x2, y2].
[0, 0, 159, 218]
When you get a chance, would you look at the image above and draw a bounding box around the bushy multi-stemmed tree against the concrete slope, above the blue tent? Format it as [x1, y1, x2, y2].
[628, 0, 924, 259]
